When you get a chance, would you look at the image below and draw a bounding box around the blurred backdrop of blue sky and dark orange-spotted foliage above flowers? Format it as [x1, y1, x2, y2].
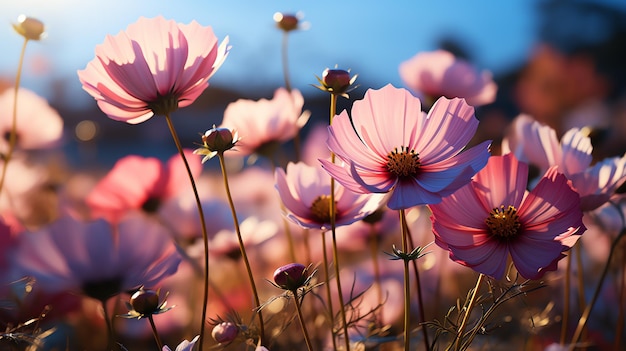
[0, 0, 626, 167]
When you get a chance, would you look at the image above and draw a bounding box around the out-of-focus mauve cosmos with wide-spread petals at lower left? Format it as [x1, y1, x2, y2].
[13, 216, 181, 301]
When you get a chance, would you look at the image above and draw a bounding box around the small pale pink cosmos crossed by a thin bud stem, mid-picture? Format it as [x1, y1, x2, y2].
[276, 162, 384, 230]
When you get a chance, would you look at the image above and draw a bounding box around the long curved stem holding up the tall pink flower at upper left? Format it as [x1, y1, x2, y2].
[165, 114, 209, 351]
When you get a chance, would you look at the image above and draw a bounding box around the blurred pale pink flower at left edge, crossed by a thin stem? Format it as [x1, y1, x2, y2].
[0, 88, 63, 152]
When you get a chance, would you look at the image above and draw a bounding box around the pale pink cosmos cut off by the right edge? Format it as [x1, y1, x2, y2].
[503, 114, 626, 211]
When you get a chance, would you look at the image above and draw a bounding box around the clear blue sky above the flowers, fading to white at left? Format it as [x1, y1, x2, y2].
[0, 0, 537, 107]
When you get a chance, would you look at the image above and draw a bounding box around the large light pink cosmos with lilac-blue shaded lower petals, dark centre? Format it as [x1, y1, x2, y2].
[320, 85, 490, 210]
